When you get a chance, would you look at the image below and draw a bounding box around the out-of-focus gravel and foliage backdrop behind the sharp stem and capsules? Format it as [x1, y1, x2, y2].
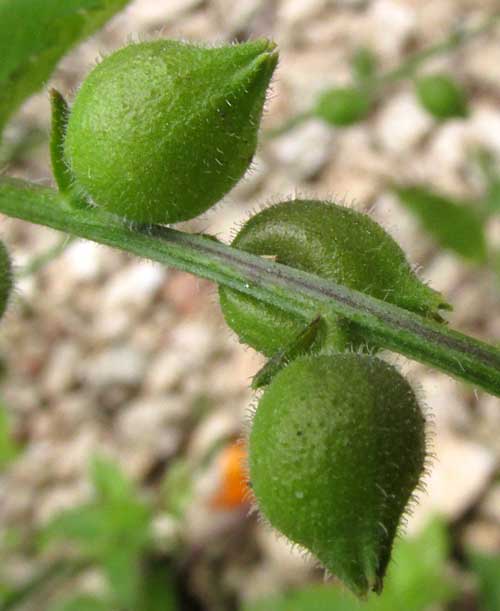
[0, 0, 500, 611]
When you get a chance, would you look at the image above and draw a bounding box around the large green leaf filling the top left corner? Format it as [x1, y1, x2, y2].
[0, 0, 129, 133]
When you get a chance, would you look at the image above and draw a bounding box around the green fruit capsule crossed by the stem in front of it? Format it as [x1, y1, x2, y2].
[219, 200, 449, 356]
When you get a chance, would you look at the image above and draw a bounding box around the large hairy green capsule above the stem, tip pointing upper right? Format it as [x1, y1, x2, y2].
[64, 39, 277, 223]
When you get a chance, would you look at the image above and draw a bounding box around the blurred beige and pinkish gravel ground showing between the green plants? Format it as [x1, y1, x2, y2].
[0, 0, 500, 598]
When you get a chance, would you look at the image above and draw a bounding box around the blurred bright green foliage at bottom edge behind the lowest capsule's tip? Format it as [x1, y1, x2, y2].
[244, 519, 455, 611]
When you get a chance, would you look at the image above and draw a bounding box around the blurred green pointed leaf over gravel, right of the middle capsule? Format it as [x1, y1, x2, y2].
[395, 185, 486, 263]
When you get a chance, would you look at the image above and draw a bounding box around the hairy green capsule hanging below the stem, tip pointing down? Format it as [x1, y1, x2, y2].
[248, 354, 426, 596]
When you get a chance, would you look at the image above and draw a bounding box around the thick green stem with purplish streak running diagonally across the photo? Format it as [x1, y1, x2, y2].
[0, 177, 500, 396]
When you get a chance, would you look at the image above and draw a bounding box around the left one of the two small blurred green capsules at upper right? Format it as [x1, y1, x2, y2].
[314, 87, 372, 127]
